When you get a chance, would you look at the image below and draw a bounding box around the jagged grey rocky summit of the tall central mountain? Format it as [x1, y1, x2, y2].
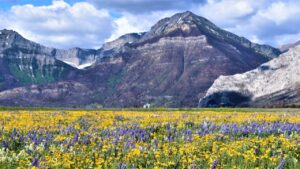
[133, 11, 281, 59]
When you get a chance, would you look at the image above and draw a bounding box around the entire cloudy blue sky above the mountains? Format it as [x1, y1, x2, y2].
[0, 0, 300, 49]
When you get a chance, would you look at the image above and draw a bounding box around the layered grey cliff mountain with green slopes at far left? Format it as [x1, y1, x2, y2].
[0, 30, 76, 90]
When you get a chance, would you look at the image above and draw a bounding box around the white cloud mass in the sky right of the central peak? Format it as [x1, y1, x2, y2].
[192, 0, 300, 46]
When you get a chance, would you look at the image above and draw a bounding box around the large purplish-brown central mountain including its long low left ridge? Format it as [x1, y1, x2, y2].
[0, 12, 280, 107]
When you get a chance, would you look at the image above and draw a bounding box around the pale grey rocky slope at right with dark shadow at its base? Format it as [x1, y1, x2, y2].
[199, 45, 300, 107]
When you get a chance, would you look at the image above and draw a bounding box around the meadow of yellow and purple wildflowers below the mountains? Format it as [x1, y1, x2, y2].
[0, 111, 300, 169]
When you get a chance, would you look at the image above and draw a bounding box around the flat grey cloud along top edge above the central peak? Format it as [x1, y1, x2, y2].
[89, 0, 206, 13]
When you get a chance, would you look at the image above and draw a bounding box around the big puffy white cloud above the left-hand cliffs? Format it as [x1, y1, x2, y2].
[0, 1, 113, 48]
